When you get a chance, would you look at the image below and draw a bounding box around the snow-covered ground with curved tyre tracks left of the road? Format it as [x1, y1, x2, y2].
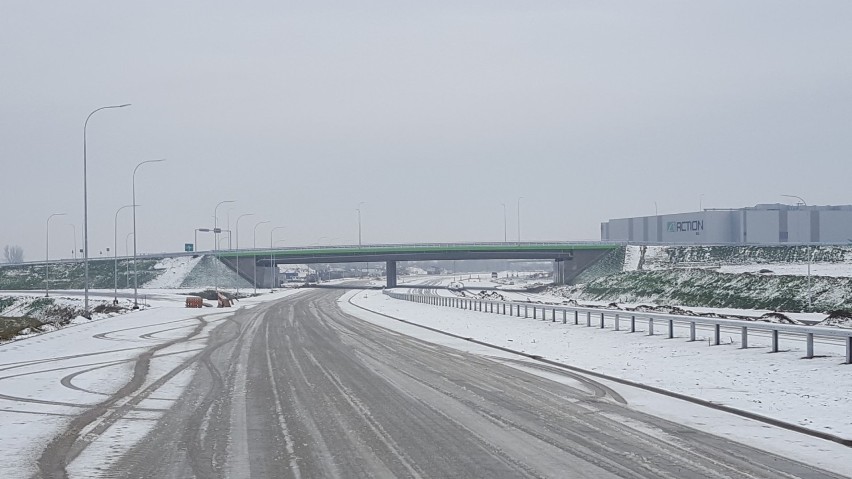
[0, 290, 298, 479]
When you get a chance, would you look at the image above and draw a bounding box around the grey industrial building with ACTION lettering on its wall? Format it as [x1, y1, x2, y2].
[601, 204, 852, 244]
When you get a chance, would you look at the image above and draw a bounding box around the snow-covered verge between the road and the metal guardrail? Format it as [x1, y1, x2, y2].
[340, 291, 852, 475]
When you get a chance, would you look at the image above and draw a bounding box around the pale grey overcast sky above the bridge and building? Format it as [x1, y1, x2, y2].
[0, 0, 852, 260]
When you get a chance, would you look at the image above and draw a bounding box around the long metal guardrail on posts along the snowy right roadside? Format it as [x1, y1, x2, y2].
[383, 290, 852, 364]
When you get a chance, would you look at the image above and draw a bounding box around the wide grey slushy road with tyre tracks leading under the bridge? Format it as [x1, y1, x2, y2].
[26, 291, 839, 479]
